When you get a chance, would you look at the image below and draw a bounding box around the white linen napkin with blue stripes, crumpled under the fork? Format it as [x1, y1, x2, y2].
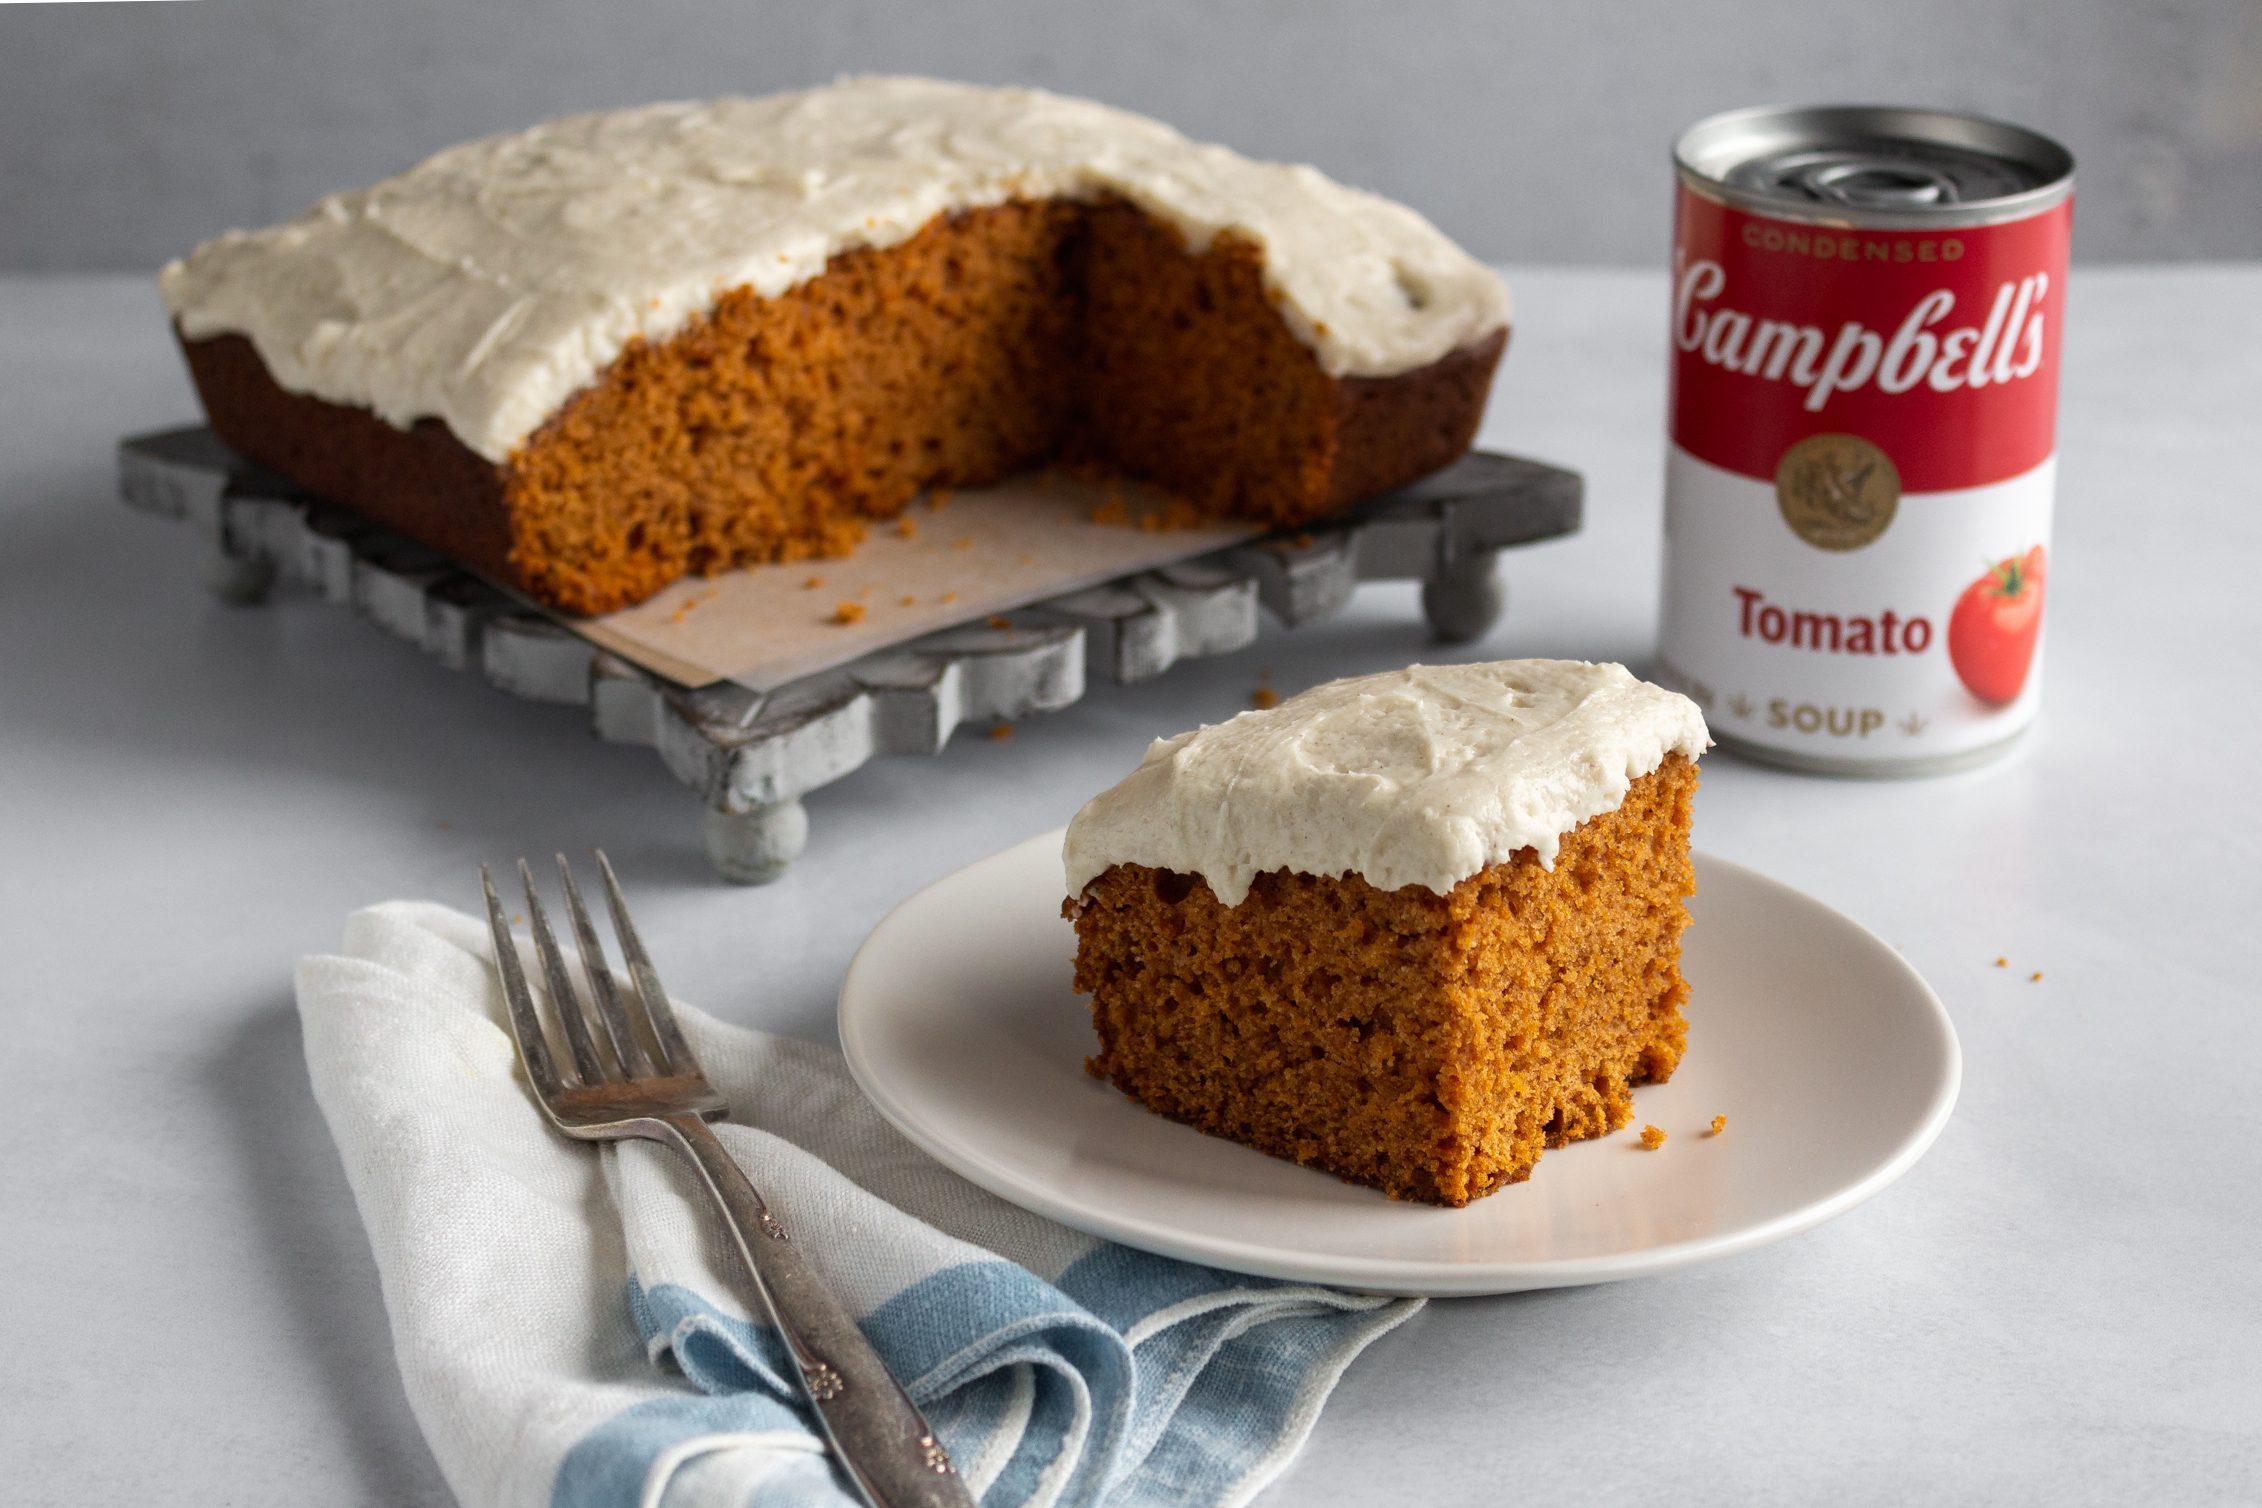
[299, 902, 1418, 1508]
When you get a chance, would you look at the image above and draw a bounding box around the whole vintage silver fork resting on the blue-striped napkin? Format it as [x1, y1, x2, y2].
[480, 850, 973, 1508]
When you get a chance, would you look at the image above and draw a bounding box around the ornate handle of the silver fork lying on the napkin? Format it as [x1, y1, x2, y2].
[661, 1115, 975, 1508]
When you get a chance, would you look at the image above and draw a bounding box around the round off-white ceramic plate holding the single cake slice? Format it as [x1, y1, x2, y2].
[839, 832, 1961, 1293]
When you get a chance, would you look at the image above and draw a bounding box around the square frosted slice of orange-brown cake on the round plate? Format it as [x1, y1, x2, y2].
[1065, 660, 1708, 1205]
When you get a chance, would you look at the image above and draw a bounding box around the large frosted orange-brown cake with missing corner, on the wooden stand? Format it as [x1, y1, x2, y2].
[158, 77, 1509, 613]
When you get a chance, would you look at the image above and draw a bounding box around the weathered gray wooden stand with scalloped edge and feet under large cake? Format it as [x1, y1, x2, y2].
[118, 427, 1581, 884]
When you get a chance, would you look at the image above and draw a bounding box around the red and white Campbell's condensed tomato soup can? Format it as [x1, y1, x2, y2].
[1663, 106, 2074, 775]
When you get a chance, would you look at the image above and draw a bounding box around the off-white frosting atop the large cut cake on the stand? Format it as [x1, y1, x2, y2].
[158, 77, 1509, 461]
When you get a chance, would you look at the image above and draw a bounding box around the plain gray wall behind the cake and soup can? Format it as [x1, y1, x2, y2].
[0, 0, 2262, 269]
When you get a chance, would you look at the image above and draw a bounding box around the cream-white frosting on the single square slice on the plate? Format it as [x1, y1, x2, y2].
[1063, 660, 1710, 907]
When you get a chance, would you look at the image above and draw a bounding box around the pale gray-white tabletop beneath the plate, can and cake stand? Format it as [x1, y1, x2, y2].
[0, 267, 2262, 1506]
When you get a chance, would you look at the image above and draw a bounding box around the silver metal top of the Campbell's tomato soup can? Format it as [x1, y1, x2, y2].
[1674, 104, 2074, 226]
